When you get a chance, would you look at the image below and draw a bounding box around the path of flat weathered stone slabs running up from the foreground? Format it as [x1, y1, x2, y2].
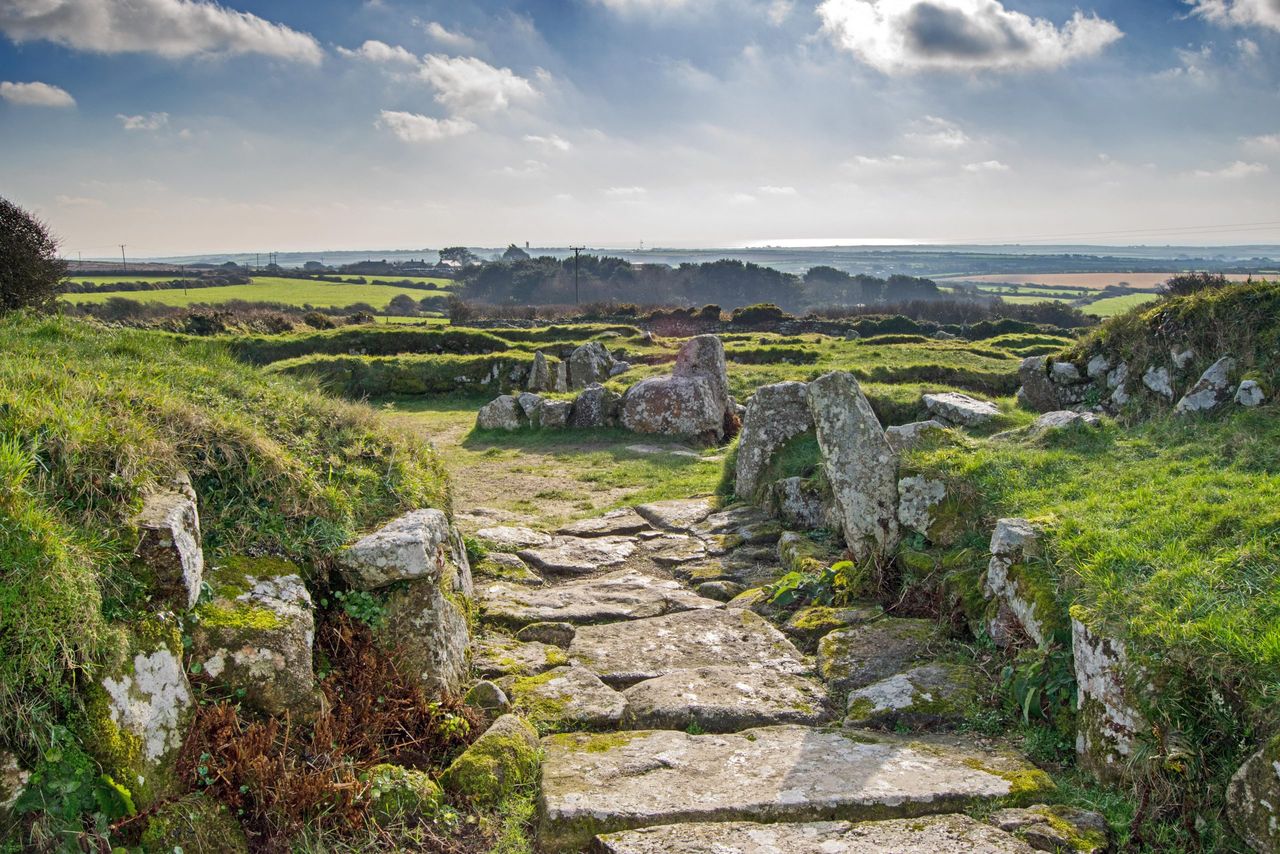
[472, 498, 1052, 854]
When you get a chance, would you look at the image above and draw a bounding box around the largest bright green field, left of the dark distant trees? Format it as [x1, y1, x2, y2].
[63, 275, 449, 309]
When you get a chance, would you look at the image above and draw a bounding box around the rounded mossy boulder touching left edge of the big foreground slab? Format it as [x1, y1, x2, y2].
[440, 714, 541, 807]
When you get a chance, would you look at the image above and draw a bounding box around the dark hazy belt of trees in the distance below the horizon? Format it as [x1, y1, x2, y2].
[458, 255, 947, 311]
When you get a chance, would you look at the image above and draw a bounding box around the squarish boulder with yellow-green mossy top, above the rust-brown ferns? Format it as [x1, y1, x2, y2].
[192, 557, 320, 718]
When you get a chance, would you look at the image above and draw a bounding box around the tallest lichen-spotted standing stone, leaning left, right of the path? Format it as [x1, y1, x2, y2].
[809, 371, 897, 560]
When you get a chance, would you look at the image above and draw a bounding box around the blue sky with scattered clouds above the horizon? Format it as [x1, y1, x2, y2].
[0, 0, 1280, 257]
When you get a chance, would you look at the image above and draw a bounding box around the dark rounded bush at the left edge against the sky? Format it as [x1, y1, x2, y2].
[0, 198, 67, 314]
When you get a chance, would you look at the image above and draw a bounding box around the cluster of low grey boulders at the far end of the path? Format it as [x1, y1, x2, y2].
[476, 335, 739, 443]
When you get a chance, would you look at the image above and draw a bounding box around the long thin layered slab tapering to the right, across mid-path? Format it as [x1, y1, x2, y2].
[476, 570, 723, 627]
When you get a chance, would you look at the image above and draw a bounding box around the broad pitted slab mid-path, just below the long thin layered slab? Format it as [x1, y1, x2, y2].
[568, 603, 808, 685]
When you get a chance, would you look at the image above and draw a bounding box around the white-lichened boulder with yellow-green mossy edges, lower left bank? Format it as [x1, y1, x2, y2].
[86, 616, 195, 808]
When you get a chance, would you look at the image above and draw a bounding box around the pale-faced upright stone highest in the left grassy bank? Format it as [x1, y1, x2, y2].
[133, 481, 205, 611]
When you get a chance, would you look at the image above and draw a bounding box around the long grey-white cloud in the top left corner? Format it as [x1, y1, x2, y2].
[0, 0, 324, 65]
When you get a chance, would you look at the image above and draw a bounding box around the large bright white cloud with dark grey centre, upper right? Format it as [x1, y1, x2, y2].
[818, 0, 1124, 74]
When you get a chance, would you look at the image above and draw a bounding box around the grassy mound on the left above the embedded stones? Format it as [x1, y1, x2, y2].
[0, 318, 448, 758]
